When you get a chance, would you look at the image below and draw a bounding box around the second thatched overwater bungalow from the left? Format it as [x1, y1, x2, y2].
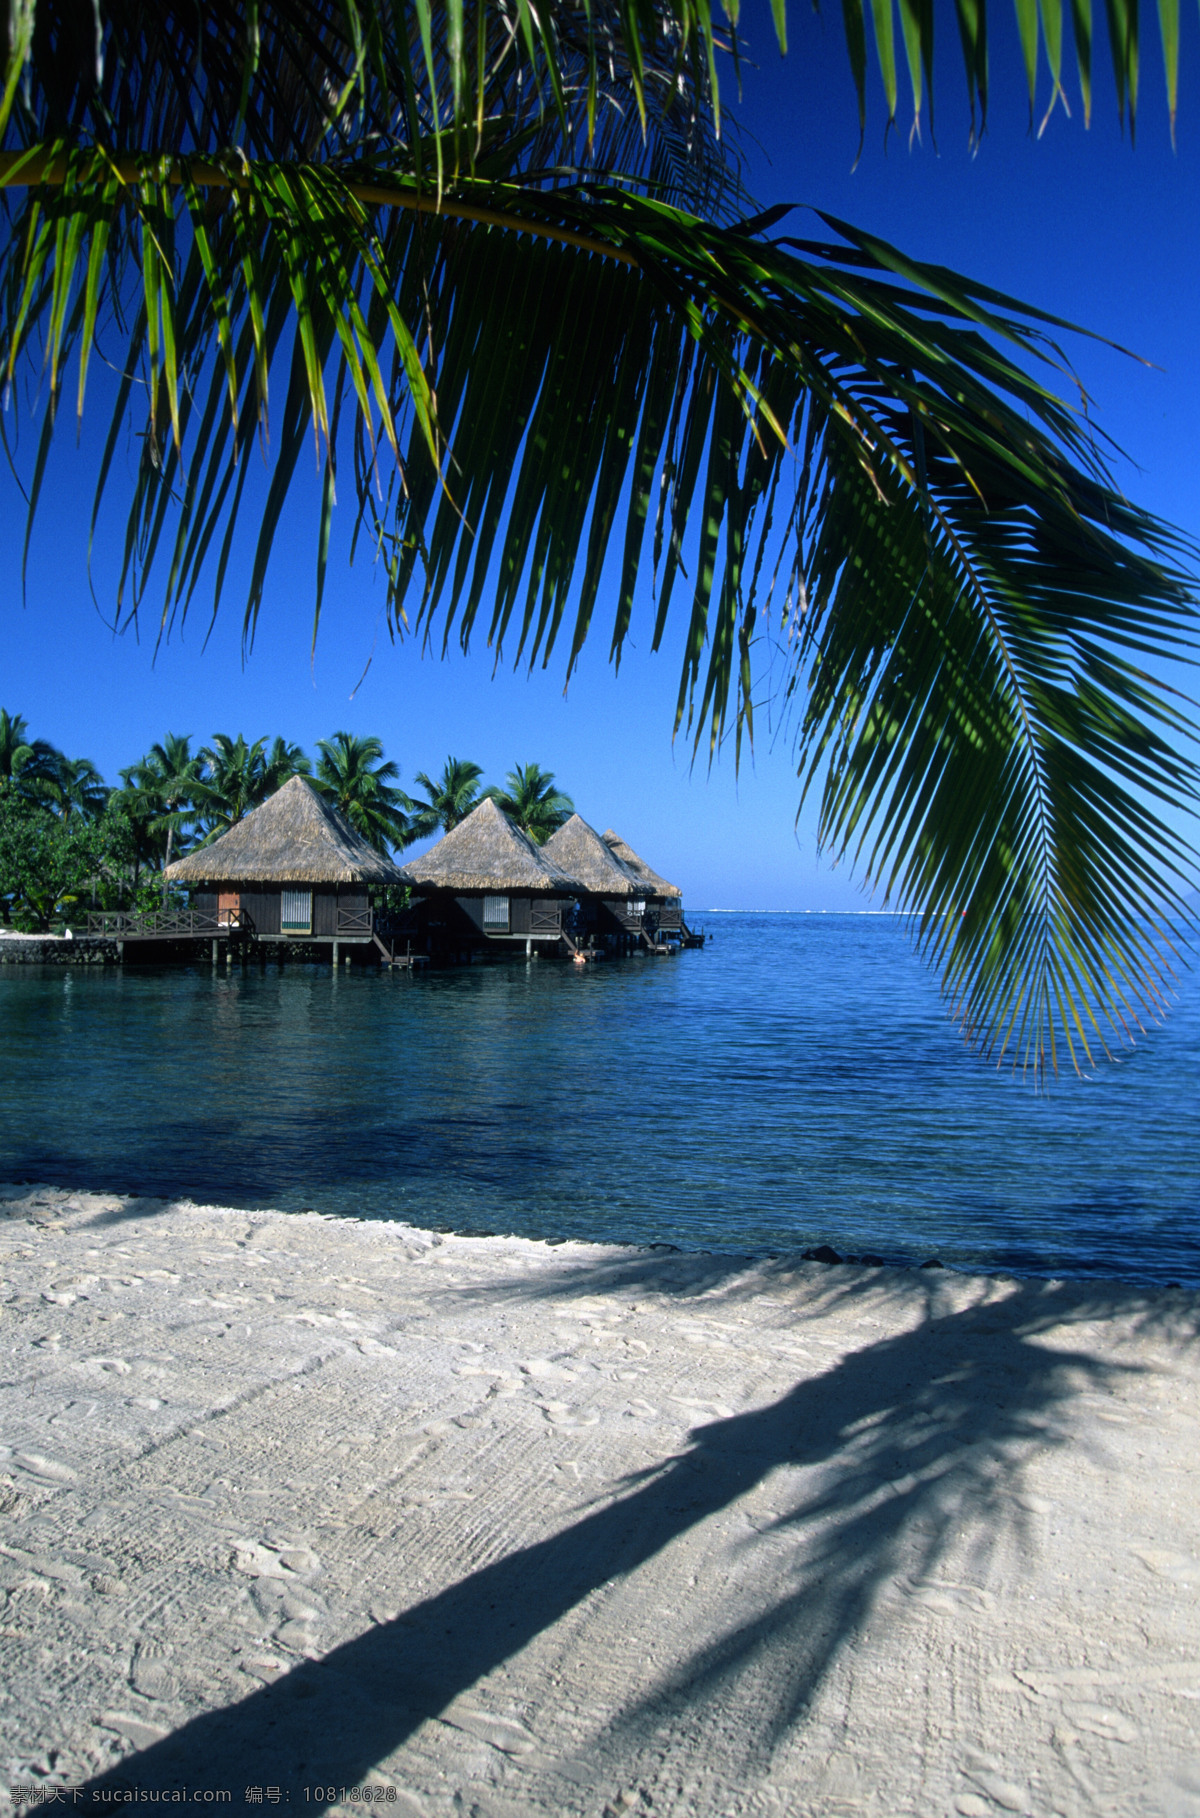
[400, 798, 582, 954]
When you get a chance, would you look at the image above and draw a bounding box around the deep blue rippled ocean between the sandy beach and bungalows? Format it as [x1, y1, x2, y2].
[0, 914, 1200, 1285]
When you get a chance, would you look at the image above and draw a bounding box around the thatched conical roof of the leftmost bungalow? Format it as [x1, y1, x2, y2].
[167, 776, 405, 884]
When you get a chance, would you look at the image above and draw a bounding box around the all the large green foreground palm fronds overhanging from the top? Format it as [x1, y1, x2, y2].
[0, 0, 1200, 1064]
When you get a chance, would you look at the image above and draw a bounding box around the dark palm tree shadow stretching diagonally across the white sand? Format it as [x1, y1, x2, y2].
[85, 1256, 1196, 1805]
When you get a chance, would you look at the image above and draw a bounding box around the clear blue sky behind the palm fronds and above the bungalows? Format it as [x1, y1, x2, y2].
[0, 5, 1200, 909]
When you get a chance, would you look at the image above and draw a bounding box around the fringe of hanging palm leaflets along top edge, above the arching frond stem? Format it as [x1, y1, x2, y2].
[0, 0, 1182, 175]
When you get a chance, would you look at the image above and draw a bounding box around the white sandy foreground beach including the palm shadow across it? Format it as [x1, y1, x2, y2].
[0, 1189, 1200, 1818]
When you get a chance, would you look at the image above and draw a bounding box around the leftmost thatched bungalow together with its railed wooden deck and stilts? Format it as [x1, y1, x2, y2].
[89, 776, 414, 965]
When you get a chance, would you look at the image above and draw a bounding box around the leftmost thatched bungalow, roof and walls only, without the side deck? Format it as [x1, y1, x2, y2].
[167, 776, 405, 942]
